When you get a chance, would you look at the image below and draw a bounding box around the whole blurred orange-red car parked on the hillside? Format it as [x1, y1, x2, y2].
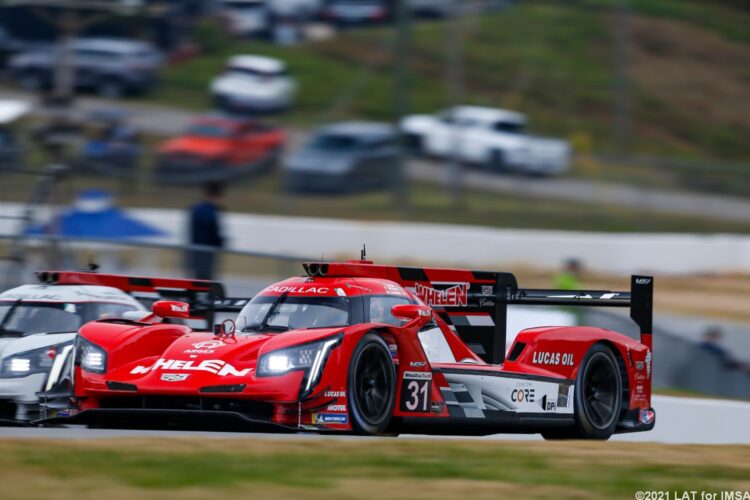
[156, 116, 286, 184]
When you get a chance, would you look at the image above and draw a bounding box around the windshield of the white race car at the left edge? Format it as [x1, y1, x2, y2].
[0, 301, 134, 337]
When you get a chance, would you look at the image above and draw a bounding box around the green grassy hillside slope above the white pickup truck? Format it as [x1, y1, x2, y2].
[140, 0, 750, 162]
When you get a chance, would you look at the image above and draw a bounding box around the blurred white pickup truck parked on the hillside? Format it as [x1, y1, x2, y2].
[401, 106, 571, 175]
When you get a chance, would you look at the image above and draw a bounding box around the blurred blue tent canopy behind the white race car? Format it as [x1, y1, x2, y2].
[25, 189, 166, 240]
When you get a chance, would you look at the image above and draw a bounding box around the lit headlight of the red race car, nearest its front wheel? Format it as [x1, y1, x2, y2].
[256, 334, 342, 391]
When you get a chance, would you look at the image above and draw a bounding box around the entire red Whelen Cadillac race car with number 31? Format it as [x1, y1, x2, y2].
[57, 260, 655, 439]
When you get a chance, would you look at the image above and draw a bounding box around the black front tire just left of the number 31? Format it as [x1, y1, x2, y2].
[347, 333, 396, 435]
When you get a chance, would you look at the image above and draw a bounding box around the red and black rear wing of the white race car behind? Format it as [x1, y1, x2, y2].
[36, 271, 226, 329]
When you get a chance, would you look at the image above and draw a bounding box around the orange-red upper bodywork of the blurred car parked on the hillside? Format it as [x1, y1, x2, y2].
[159, 117, 286, 166]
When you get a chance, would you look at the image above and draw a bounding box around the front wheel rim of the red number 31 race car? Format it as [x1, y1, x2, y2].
[354, 345, 391, 424]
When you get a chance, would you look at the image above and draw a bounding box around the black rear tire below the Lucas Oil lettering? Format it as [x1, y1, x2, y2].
[542, 344, 622, 440]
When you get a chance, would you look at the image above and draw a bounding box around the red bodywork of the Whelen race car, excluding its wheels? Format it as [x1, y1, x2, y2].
[74, 261, 654, 434]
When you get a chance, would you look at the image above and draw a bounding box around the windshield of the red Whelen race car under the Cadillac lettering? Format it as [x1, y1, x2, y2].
[237, 295, 351, 332]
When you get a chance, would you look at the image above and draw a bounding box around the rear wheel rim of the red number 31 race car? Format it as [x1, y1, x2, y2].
[583, 353, 619, 429]
